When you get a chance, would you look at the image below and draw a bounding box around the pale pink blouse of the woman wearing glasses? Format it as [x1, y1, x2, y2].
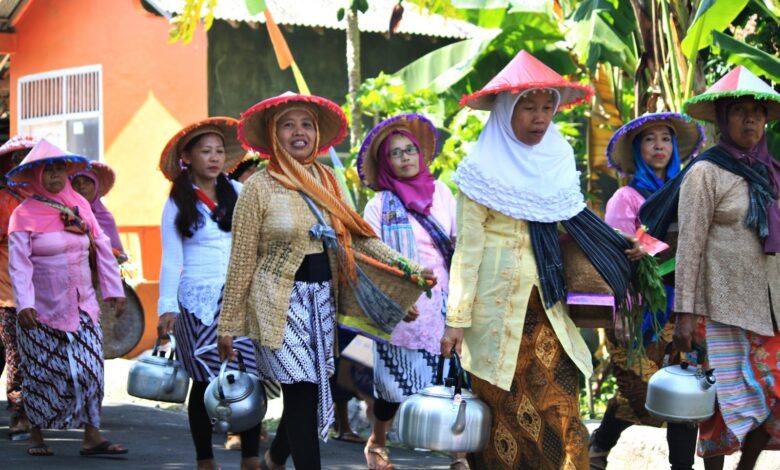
[364, 181, 457, 354]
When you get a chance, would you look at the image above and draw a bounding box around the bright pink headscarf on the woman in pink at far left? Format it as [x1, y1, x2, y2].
[8, 163, 103, 236]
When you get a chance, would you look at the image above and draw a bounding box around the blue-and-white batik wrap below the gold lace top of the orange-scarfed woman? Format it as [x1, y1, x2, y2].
[255, 281, 336, 442]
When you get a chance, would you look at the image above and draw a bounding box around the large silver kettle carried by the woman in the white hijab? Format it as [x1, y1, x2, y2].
[398, 351, 492, 452]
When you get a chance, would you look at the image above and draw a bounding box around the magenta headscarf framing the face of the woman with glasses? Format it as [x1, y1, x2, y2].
[377, 129, 435, 215]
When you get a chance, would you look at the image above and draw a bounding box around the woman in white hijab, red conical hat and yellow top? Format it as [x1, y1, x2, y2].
[441, 51, 641, 469]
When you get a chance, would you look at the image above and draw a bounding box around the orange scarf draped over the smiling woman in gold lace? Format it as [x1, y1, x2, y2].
[267, 108, 378, 282]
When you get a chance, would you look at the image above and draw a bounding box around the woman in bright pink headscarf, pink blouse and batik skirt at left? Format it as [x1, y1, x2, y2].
[6, 140, 127, 456]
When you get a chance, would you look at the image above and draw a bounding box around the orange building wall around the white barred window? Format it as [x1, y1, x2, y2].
[11, 0, 208, 279]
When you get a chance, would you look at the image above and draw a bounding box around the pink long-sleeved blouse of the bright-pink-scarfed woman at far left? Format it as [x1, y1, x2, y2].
[8, 230, 125, 331]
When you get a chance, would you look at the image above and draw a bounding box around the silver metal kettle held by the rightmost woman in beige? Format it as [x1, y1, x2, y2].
[645, 343, 716, 423]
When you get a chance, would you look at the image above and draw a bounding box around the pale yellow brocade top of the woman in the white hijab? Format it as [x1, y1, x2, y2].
[447, 193, 593, 390]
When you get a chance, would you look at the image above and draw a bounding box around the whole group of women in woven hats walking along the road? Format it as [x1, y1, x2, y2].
[0, 47, 780, 470]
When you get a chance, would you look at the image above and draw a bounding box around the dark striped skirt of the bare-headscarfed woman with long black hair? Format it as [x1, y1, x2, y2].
[173, 299, 257, 382]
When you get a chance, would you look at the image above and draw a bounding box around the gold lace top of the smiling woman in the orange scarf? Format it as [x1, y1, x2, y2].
[218, 168, 412, 349]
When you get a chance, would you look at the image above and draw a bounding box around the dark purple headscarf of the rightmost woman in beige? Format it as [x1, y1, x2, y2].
[715, 98, 780, 253]
